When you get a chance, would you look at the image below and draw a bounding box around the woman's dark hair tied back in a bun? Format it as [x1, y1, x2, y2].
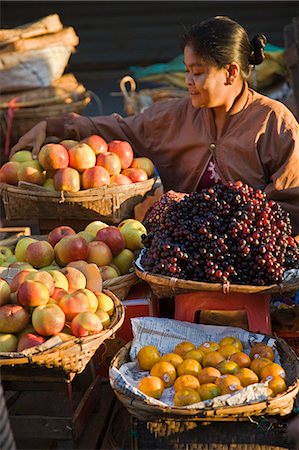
[181, 16, 267, 79]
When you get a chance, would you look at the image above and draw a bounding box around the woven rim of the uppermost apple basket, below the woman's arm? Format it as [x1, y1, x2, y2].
[0, 177, 156, 201]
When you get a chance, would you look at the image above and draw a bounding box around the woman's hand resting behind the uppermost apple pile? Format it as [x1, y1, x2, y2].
[9, 120, 47, 159]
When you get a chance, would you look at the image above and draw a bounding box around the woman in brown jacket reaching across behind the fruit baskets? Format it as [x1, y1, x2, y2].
[12, 16, 299, 239]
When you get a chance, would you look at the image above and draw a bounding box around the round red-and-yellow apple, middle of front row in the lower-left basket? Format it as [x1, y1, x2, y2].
[31, 303, 66, 336]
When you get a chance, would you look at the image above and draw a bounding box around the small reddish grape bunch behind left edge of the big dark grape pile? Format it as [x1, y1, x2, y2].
[142, 191, 188, 233]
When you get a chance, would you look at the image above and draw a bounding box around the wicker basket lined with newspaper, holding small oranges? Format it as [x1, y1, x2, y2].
[111, 339, 299, 421]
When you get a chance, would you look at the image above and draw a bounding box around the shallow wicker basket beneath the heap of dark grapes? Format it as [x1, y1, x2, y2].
[135, 249, 299, 298]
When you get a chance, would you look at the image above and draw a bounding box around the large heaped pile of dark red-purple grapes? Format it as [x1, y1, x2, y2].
[141, 181, 299, 286]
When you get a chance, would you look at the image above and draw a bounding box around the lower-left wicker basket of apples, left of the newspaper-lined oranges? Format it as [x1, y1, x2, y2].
[0, 290, 125, 373]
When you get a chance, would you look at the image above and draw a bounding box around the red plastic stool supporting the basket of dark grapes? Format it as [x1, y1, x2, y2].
[174, 291, 272, 334]
